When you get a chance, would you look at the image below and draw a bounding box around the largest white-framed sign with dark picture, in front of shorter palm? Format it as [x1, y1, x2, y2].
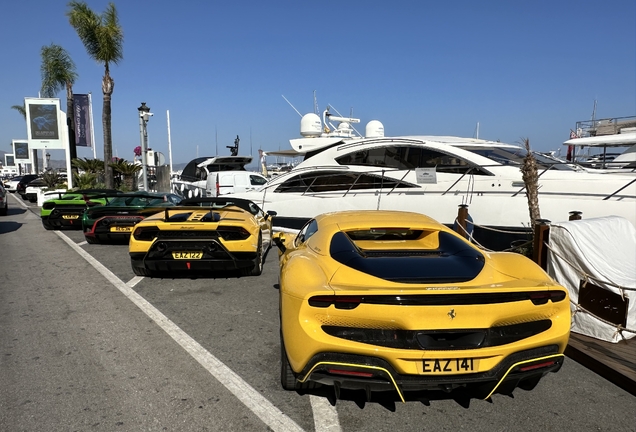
[24, 98, 66, 150]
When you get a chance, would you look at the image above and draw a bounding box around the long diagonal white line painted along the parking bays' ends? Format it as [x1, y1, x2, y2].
[55, 231, 306, 432]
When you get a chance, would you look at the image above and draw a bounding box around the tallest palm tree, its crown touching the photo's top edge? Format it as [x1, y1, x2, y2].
[66, 1, 124, 188]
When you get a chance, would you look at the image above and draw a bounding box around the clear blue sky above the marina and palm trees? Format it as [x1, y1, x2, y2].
[0, 0, 636, 164]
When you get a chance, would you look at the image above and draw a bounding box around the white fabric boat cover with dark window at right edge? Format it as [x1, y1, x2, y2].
[547, 216, 636, 343]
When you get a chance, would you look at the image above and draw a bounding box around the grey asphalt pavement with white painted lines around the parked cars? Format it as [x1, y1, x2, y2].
[0, 195, 636, 432]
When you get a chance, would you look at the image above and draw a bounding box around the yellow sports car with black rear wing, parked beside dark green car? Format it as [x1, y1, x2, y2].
[128, 197, 276, 277]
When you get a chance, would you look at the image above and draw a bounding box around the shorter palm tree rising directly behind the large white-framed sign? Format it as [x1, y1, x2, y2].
[40, 44, 77, 160]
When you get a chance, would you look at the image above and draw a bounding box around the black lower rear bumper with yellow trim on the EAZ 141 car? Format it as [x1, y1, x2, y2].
[297, 345, 564, 401]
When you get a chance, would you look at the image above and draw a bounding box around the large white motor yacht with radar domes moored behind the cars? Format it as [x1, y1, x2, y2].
[235, 112, 636, 250]
